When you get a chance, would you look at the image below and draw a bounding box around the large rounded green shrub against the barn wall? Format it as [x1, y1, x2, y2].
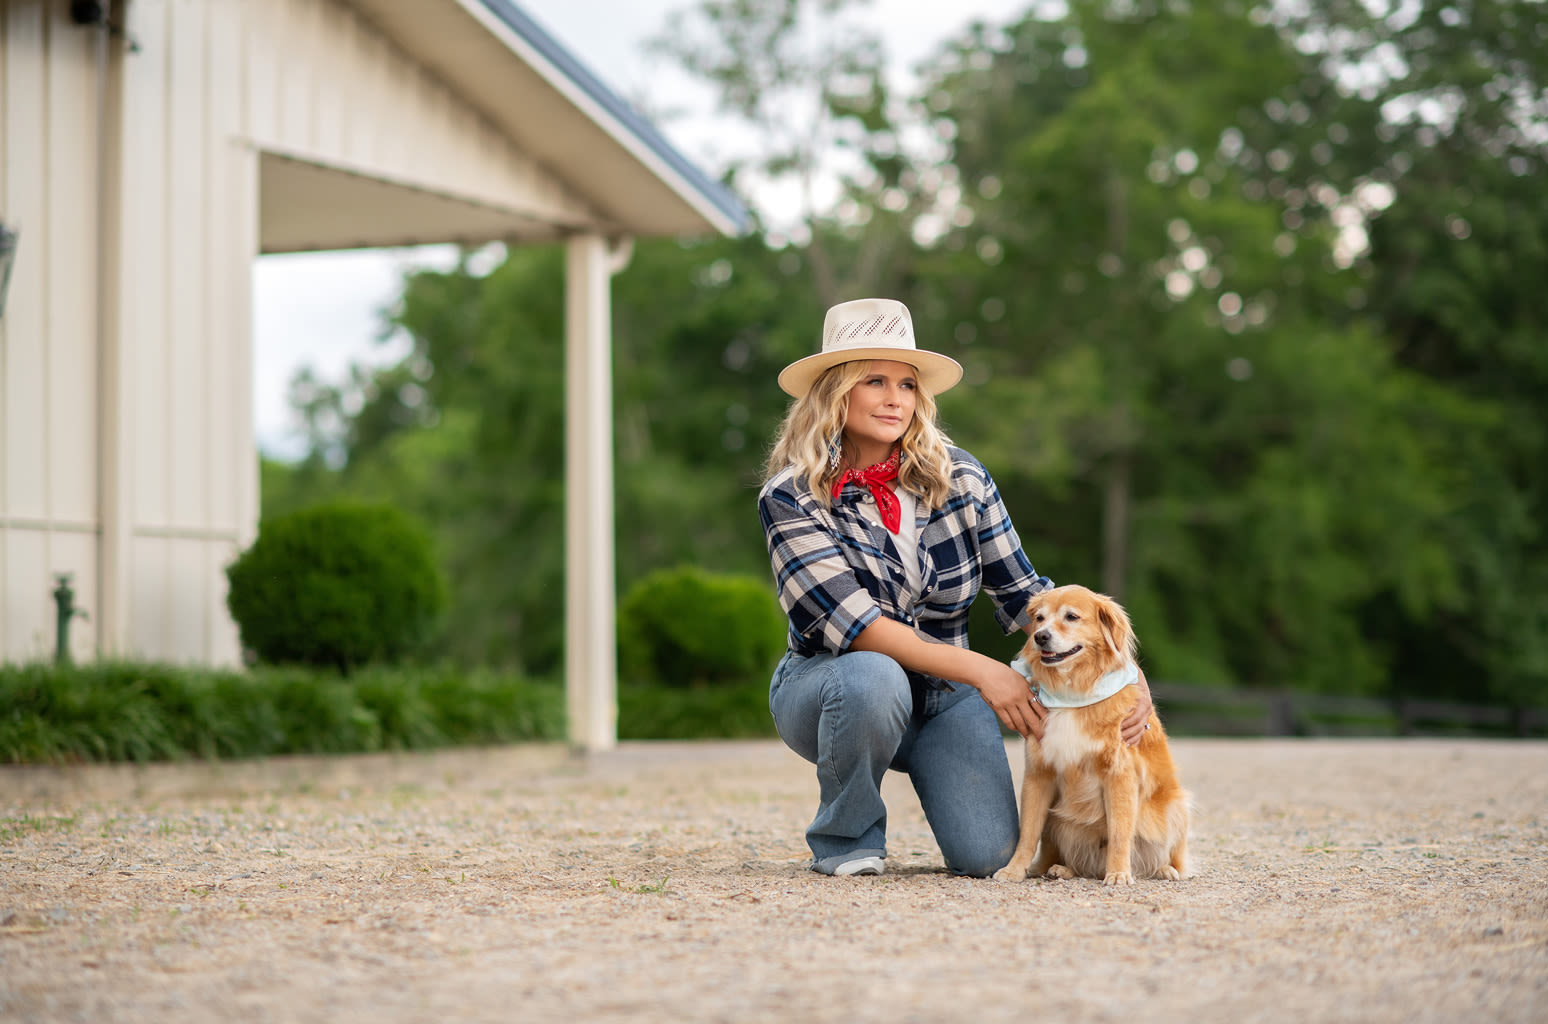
[226, 503, 446, 671]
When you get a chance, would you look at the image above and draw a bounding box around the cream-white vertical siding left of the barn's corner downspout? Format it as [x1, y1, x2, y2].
[0, 0, 99, 660]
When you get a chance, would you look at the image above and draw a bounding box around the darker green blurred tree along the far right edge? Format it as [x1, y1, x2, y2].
[1286, 0, 1548, 702]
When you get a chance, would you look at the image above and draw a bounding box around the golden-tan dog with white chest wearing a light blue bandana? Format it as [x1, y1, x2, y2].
[994, 586, 1190, 885]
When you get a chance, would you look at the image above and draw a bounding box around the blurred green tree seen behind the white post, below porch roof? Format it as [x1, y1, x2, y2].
[280, 237, 820, 674]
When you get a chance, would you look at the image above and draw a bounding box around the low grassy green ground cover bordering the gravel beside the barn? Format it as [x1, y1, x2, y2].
[0, 661, 776, 764]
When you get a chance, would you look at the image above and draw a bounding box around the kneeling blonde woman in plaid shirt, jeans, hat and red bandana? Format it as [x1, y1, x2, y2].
[759, 299, 1150, 877]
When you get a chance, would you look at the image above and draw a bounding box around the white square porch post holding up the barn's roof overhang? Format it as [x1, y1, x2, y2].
[565, 235, 618, 751]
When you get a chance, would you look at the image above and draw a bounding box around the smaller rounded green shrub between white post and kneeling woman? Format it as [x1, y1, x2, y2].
[618, 565, 786, 686]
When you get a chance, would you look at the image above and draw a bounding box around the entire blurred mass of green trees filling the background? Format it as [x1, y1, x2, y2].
[263, 0, 1548, 705]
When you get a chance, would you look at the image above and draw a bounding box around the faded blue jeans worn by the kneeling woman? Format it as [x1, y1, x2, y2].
[769, 651, 1017, 877]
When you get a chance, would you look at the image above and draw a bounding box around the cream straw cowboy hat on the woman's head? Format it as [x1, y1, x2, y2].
[779, 299, 963, 398]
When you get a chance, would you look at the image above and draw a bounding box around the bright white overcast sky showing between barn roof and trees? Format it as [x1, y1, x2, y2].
[252, 0, 1034, 459]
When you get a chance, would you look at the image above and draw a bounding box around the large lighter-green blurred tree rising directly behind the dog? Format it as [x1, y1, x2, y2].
[924, 3, 1485, 691]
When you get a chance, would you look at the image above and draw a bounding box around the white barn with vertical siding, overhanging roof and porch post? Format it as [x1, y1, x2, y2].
[0, 0, 748, 748]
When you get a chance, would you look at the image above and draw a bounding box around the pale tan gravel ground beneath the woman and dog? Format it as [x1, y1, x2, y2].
[0, 741, 1548, 1024]
